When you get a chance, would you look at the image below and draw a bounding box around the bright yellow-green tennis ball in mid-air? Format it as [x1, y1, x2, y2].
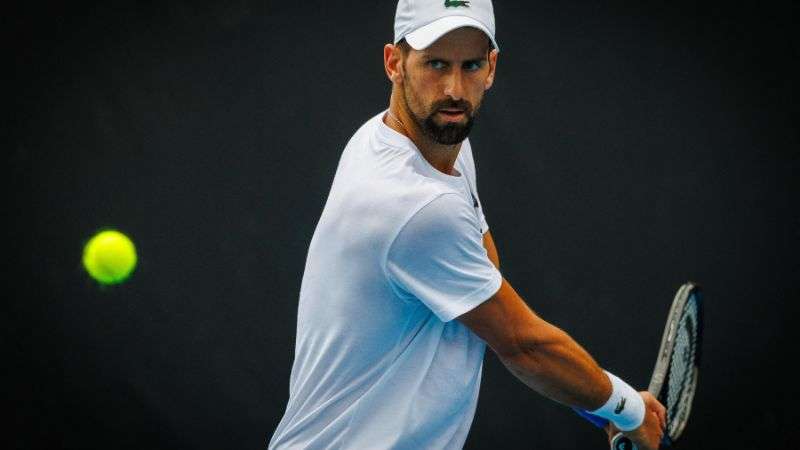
[83, 230, 136, 284]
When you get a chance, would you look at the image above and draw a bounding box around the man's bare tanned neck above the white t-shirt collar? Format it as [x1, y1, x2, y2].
[383, 101, 461, 175]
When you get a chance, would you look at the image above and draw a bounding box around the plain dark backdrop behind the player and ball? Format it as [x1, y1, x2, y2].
[9, 0, 800, 449]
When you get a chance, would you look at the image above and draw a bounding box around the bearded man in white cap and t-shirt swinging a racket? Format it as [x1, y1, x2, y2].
[269, 0, 665, 449]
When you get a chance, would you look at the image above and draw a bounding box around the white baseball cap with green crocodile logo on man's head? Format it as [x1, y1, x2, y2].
[394, 0, 500, 51]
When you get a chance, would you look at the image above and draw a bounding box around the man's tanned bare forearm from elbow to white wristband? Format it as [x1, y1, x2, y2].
[500, 320, 611, 411]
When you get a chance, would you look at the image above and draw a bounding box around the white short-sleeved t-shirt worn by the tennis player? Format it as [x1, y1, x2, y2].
[269, 110, 502, 449]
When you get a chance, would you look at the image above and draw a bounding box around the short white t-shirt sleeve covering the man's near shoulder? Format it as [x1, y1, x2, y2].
[385, 193, 502, 322]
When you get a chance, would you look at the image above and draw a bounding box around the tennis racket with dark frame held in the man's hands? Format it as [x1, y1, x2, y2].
[575, 282, 703, 450]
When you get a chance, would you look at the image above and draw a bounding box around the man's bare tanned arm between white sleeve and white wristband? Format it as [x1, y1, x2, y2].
[458, 276, 611, 411]
